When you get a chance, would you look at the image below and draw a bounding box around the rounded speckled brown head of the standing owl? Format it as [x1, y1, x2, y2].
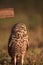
[11, 23, 27, 33]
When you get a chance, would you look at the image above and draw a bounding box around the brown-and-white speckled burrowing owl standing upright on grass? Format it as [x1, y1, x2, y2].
[8, 23, 29, 65]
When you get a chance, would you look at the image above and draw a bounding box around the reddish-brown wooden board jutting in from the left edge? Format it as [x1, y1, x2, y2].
[0, 8, 14, 18]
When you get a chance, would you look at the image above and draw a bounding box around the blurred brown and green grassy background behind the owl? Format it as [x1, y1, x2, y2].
[0, 0, 43, 65]
